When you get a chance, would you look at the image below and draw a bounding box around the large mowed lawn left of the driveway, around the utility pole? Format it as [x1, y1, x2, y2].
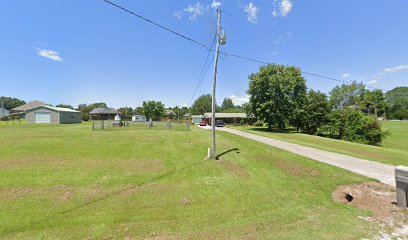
[0, 124, 374, 239]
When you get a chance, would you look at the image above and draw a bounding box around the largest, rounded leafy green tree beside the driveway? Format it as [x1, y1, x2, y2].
[247, 64, 306, 129]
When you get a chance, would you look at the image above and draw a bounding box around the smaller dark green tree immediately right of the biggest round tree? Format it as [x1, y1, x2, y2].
[302, 90, 331, 135]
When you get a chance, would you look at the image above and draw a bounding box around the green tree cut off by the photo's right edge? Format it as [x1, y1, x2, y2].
[385, 87, 408, 119]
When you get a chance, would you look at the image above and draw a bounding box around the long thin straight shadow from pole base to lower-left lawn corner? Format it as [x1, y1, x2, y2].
[0, 161, 205, 237]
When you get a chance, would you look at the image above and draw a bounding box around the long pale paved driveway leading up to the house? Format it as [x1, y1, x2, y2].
[201, 127, 395, 186]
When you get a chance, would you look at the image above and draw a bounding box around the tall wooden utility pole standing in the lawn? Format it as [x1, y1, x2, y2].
[211, 9, 221, 158]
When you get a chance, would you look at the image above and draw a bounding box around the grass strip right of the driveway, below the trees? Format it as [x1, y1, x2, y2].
[232, 121, 408, 165]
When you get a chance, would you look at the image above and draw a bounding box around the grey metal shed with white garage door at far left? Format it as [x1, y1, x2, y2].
[25, 105, 82, 124]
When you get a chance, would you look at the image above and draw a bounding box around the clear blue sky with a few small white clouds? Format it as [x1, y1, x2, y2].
[0, 0, 408, 107]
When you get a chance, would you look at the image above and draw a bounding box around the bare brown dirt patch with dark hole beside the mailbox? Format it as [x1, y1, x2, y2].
[332, 182, 408, 239]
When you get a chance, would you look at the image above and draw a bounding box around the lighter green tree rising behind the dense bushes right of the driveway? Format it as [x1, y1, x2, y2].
[330, 82, 366, 109]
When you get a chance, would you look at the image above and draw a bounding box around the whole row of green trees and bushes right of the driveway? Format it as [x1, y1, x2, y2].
[244, 64, 408, 144]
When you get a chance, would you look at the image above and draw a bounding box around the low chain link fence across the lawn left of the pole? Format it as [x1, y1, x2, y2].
[92, 120, 191, 131]
